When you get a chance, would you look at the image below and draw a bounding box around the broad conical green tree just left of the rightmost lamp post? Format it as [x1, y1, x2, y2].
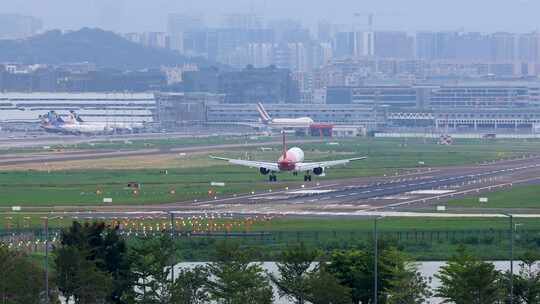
[435, 248, 504, 304]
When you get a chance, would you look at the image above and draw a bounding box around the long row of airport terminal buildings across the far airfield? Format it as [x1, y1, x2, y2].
[0, 85, 540, 133]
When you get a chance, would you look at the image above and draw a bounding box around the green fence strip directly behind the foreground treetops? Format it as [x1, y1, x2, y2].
[0, 229, 540, 261]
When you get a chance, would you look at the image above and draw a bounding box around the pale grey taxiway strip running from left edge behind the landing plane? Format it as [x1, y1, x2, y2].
[0, 139, 321, 167]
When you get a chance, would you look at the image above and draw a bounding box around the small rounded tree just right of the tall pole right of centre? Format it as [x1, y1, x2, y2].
[386, 263, 432, 304]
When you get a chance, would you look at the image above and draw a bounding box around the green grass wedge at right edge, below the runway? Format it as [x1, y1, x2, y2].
[448, 185, 540, 209]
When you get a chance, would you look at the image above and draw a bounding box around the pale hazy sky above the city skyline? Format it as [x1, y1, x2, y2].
[0, 0, 540, 32]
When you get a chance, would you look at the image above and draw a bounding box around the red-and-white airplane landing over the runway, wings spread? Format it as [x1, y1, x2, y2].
[210, 132, 367, 182]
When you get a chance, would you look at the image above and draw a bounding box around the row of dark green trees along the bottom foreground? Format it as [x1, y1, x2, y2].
[0, 222, 540, 304]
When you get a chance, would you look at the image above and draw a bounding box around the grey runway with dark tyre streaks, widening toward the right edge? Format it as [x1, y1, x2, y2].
[34, 157, 540, 216]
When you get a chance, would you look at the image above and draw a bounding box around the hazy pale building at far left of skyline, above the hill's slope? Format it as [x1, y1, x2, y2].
[0, 14, 43, 39]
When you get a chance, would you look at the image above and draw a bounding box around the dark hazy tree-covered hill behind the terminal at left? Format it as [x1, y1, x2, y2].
[0, 28, 215, 69]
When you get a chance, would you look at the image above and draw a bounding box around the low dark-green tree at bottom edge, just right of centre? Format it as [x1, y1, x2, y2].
[305, 264, 351, 304]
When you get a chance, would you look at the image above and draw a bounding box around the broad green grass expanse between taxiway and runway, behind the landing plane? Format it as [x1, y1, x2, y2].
[0, 138, 540, 206]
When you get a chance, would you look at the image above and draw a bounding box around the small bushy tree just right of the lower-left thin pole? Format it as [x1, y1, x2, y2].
[172, 266, 210, 304]
